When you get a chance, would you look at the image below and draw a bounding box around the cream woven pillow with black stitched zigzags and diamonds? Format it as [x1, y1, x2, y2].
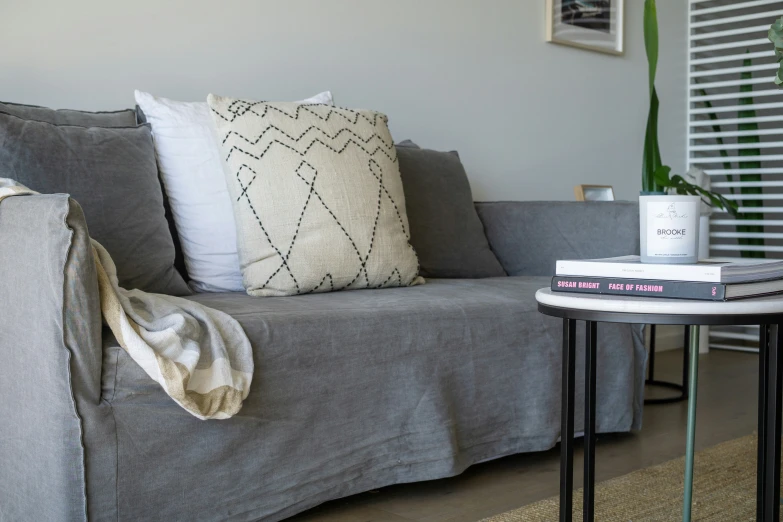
[207, 94, 424, 296]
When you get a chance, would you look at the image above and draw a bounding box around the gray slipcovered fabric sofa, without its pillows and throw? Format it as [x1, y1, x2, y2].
[0, 195, 645, 521]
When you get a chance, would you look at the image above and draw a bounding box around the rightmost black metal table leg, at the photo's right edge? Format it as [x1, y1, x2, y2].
[759, 324, 783, 522]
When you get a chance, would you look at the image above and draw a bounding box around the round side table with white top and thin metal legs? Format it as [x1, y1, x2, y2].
[536, 288, 783, 522]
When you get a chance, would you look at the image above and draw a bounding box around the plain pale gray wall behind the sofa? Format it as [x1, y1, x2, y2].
[0, 0, 686, 200]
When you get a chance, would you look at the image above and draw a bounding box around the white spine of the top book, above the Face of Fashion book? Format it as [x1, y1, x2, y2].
[556, 261, 721, 283]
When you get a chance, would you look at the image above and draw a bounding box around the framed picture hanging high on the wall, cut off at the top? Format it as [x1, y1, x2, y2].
[546, 0, 625, 54]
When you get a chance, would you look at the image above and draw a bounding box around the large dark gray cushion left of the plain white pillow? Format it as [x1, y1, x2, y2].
[0, 112, 190, 295]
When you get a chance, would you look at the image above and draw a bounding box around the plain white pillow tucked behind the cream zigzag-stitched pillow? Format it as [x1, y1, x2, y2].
[135, 91, 333, 292]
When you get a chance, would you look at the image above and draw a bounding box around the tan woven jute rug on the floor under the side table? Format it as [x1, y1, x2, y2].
[482, 435, 756, 522]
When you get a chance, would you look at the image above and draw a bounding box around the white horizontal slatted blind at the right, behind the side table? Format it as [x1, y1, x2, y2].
[687, 0, 783, 350]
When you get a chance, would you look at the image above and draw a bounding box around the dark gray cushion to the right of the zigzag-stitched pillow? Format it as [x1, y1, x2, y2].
[397, 140, 506, 278]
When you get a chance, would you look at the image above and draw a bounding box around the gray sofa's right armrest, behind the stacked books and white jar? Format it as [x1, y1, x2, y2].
[476, 201, 639, 276]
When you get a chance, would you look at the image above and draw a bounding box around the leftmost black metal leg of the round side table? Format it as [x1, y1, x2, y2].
[560, 319, 576, 522]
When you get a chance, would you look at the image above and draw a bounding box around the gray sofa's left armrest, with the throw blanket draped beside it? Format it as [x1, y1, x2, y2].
[0, 194, 102, 520]
